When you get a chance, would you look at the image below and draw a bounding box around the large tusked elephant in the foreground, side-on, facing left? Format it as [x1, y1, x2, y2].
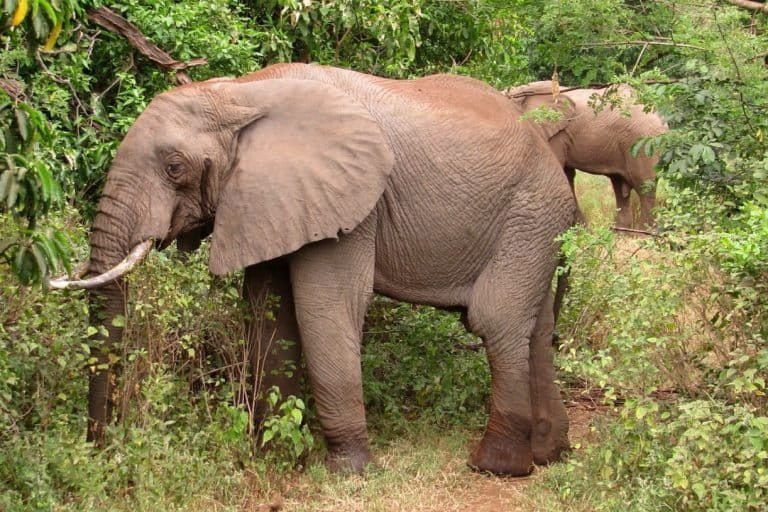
[51, 64, 576, 475]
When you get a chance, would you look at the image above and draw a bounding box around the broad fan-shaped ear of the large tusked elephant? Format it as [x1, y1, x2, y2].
[209, 79, 394, 275]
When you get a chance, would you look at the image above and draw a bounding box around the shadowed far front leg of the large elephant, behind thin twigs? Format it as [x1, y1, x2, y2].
[243, 260, 302, 428]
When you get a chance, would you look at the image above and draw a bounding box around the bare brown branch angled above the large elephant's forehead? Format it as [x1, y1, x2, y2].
[88, 7, 208, 85]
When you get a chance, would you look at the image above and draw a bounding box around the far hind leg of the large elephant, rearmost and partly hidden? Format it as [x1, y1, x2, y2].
[529, 293, 570, 464]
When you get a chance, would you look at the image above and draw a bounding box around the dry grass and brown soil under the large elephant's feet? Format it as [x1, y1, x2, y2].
[254, 400, 606, 512]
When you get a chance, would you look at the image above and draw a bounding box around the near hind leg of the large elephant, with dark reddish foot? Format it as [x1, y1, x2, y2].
[462, 243, 554, 476]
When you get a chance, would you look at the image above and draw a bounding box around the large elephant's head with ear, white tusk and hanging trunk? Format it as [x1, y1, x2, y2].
[51, 76, 393, 444]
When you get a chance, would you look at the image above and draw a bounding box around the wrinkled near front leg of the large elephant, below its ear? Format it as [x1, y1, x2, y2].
[291, 225, 374, 473]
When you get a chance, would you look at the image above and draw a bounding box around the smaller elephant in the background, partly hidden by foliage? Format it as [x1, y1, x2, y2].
[505, 81, 668, 228]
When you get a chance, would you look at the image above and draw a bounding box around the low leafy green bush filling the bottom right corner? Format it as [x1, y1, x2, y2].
[543, 400, 768, 512]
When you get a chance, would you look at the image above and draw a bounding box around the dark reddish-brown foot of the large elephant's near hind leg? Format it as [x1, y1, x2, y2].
[469, 432, 533, 476]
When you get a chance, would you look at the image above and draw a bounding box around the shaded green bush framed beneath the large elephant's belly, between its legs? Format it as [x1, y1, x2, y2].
[363, 299, 490, 428]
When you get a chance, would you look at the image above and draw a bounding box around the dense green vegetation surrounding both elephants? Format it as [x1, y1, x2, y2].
[0, 0, 768, 511]
